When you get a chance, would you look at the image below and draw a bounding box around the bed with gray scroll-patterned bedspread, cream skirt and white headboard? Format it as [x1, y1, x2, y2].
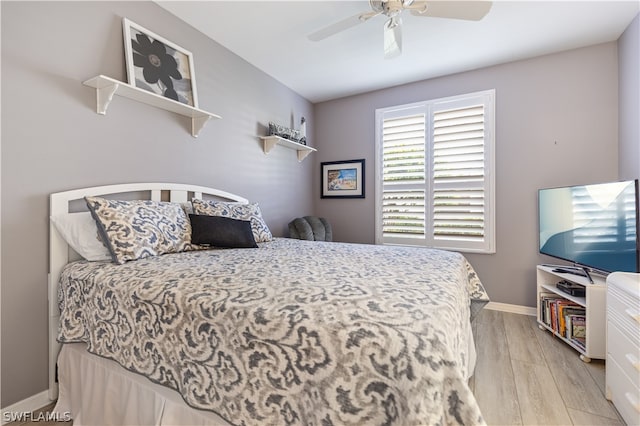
[49, 183, 488, 425]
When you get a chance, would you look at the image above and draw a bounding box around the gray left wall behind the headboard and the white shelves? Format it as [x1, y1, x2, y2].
[1, 1, 315, 407]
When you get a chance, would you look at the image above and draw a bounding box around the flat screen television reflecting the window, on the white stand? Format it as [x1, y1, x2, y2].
[538, 179, 640, 274]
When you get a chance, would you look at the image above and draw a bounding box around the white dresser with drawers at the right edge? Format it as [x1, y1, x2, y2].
[606, 272, 640, 425]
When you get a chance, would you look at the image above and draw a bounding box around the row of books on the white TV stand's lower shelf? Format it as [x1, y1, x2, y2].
[540, 293, 586, 350]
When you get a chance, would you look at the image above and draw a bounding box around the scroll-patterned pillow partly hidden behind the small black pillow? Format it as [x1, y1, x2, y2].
[191, 199, 273, 243]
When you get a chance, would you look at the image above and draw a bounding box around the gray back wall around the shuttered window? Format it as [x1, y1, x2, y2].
[314, 42, 624, 306]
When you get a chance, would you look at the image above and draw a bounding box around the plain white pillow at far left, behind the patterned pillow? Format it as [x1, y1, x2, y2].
[51, 212, 111, 262]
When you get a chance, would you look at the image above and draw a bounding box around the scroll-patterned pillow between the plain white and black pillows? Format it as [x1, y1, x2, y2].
[85, 197, 192, 264]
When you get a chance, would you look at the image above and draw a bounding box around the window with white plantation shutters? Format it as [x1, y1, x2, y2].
[376, 90, 495, 253]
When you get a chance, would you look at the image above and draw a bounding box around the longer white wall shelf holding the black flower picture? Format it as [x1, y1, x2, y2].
[82, 75, 221, 138]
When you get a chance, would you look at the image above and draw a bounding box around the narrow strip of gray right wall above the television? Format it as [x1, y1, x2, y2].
[618, 14, 640, 180]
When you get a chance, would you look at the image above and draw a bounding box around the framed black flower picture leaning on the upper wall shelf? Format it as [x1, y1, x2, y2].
[122, 18, 198, 108]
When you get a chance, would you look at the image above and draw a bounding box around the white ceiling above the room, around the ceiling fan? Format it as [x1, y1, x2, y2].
[157, 0, 640, 103]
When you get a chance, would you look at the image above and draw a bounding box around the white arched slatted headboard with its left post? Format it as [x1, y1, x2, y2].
[48, 183, 249, 401]
